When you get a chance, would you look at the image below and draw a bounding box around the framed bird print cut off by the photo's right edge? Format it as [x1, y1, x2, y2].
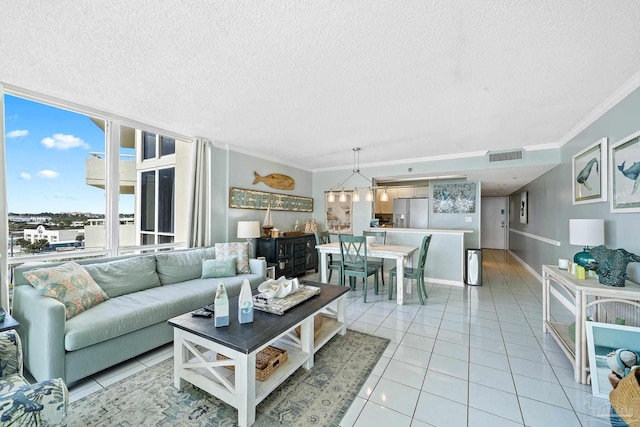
[609, 132, 640, 213]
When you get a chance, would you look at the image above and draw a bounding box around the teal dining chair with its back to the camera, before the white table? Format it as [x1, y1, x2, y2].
[338, 234, 380, 302]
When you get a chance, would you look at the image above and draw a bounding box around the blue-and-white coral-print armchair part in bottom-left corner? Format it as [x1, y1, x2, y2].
[0, 378, 69, 426]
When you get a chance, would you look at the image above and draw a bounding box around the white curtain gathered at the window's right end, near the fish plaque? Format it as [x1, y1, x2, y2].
[188, 138, 213, 248]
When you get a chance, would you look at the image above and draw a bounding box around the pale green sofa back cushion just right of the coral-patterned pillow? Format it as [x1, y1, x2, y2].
[84, 256, 160, 298]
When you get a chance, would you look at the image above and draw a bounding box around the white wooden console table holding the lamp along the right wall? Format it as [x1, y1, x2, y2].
[542, 265, 640, 384]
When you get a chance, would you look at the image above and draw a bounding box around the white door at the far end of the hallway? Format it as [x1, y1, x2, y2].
[480, 197, 508, 249]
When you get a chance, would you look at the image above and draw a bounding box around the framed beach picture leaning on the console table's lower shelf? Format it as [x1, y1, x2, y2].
[585, 322, 640, 399]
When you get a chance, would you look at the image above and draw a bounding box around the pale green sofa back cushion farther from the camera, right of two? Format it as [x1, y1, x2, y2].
[156, 248, 216, 285]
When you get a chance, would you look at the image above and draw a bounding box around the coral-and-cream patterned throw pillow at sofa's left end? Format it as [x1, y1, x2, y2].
[23, 262, 109, 320]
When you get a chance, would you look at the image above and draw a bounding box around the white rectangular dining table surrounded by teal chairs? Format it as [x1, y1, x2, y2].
[316, 242, 418, 305]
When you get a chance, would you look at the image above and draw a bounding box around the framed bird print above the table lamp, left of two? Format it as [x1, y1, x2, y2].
[571, 138, 608, 205]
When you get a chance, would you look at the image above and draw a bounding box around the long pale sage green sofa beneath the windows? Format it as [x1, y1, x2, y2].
[12, 248, 267, 384]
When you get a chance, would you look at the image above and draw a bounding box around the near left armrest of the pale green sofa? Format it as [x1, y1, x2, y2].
[12, 286, 67, 381]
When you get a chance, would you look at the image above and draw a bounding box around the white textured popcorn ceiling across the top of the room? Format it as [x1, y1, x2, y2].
[0, 0, 640, 192]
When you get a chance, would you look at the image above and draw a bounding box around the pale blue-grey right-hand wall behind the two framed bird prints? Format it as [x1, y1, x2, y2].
[509, 90, 640, 282]
